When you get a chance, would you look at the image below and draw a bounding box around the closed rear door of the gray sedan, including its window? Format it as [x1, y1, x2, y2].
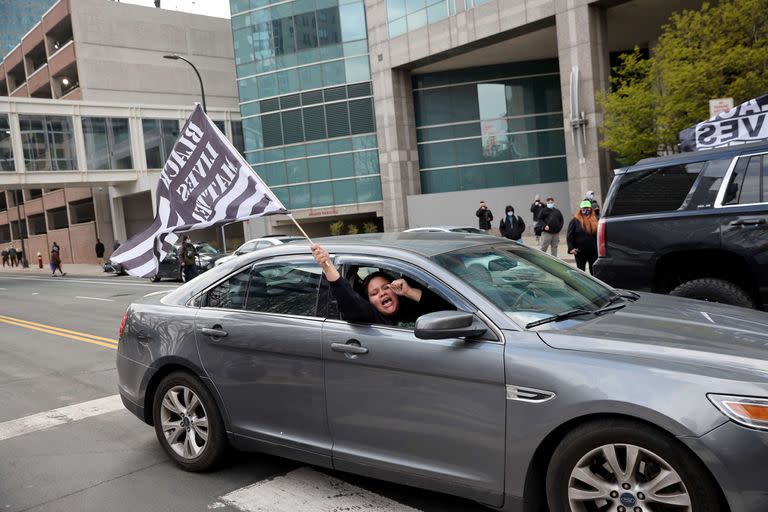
[195, 257, 331, 464]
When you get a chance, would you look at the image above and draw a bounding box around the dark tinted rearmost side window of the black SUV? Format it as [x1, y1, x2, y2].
[609, 162, 704, 215]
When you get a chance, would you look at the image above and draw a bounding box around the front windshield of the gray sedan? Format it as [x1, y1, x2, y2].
[433, 244, 616, 325]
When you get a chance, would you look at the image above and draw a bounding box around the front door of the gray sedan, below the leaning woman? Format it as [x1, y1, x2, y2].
[323, 256, 506, 505]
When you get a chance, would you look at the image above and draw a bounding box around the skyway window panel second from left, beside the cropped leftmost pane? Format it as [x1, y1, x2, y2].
[19, 115, 77, 171]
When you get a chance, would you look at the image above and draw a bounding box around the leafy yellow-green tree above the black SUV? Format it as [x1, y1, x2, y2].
[598, 0, 768, 163]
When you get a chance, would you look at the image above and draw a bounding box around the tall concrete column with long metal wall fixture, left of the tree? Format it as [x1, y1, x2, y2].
[555, 0, 610, 212]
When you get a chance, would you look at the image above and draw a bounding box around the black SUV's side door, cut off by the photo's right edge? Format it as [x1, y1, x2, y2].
[718, 154, 768, 304]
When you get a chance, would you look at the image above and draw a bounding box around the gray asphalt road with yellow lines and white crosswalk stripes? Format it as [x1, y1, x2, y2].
[0, 273, 488, 512]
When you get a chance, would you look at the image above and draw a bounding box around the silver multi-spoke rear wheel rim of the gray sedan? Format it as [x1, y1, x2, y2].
[160, 386, 208, 460]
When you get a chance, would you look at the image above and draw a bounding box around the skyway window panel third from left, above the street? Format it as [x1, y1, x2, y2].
[83, 117, 133, 170]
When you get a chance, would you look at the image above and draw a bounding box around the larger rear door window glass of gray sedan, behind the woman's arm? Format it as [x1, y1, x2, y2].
[245, 261, 322, 316]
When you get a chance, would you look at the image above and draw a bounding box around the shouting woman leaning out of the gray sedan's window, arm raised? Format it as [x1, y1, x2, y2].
[312, 244, 453, 325]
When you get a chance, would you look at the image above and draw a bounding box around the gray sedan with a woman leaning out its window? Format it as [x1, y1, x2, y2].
[117, 233, 768, 512]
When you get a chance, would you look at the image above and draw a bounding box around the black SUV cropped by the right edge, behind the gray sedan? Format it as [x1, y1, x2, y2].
[595, 142, 768, 309]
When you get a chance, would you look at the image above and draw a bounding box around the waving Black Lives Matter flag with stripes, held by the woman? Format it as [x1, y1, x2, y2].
[110, 105, 289, 277]
